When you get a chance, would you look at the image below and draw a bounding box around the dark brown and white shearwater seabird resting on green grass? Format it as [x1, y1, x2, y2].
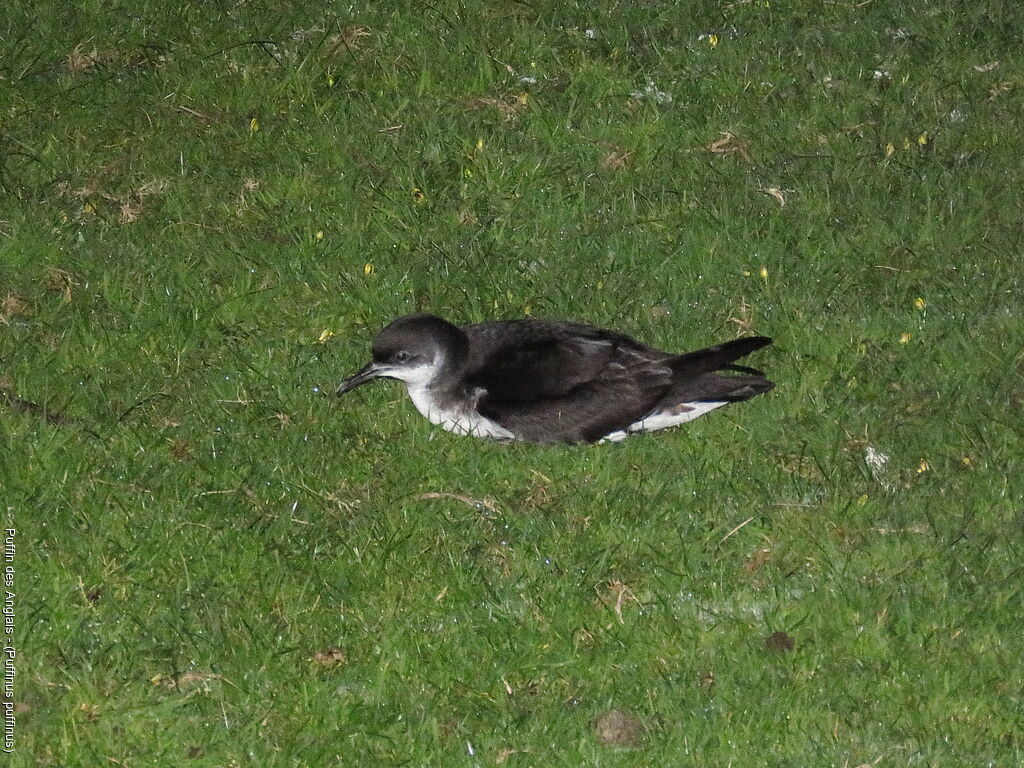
[337, 314, 775, 443]
